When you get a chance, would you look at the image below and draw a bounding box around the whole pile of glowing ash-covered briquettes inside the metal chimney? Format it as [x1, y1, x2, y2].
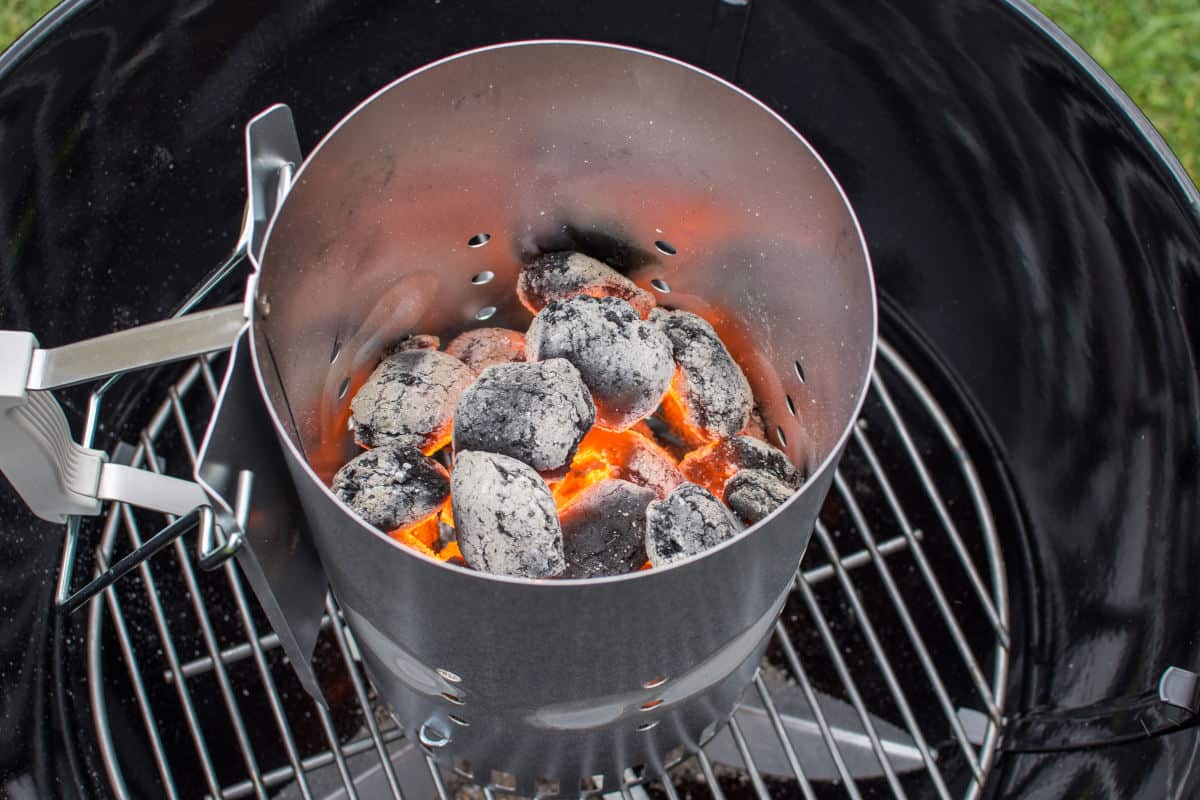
[330, 252, 814, 578]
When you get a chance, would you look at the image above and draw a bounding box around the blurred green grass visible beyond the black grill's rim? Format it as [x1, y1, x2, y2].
[0, 0, 1200, 179]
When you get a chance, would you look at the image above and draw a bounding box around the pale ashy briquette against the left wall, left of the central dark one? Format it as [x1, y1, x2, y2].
[350, 349, 475, 452]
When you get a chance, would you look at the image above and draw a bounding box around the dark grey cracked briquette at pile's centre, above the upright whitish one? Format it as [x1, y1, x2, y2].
[454, 359, 595, 473]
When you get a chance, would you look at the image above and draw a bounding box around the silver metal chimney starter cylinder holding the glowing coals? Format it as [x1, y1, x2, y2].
[254, 41, 876, 795]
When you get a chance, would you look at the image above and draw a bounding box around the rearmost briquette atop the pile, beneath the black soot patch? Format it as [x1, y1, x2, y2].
[517, 252, 655, 318]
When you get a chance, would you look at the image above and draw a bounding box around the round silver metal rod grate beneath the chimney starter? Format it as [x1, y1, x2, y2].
[79, 335, 1008, 800]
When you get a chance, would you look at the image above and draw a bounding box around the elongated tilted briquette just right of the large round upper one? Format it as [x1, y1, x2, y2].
[649, 308, 754, 439]
